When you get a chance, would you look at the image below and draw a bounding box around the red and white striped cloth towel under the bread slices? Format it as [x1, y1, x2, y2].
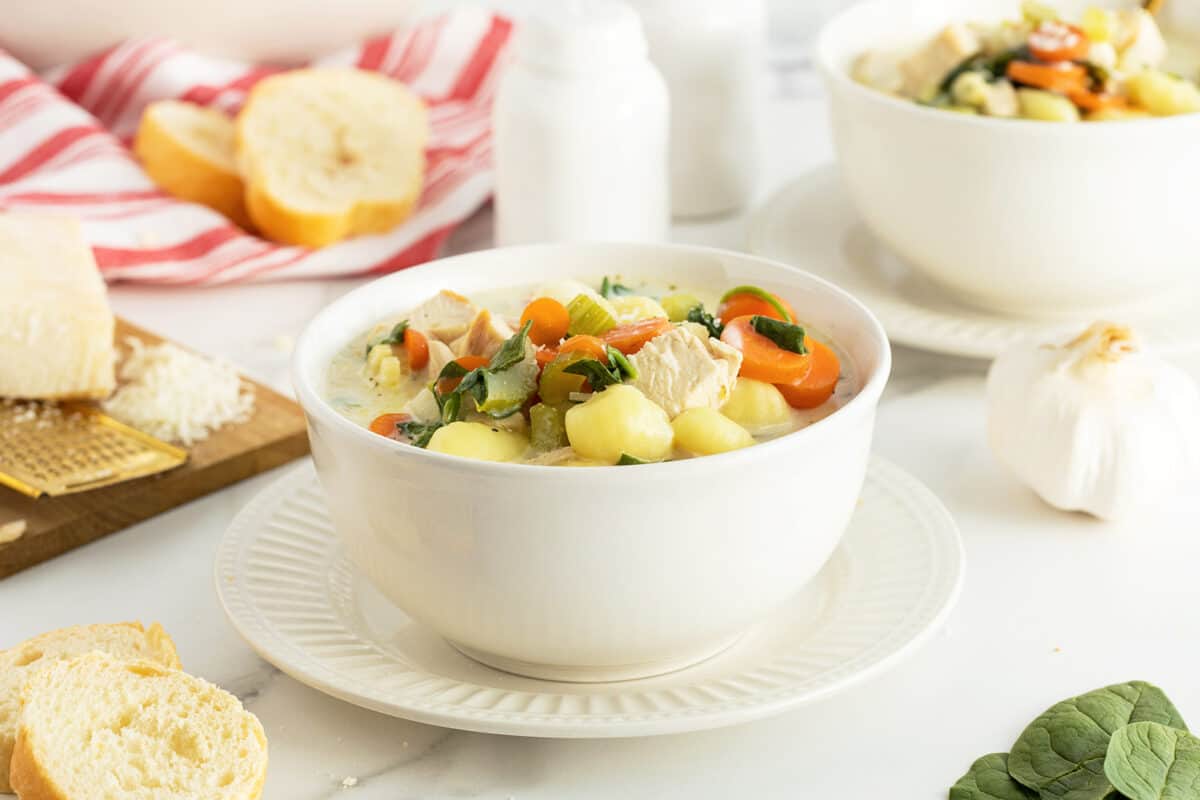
[0, 8, 511, 284]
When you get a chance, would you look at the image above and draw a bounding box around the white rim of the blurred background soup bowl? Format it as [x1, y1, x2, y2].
[814, 0, 1200, 138]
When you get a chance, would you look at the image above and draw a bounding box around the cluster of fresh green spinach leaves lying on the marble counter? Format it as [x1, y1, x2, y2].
[949, 681, 1200, 800]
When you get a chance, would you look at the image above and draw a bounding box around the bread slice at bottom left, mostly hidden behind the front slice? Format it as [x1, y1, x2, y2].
[0, 622, 179, 792]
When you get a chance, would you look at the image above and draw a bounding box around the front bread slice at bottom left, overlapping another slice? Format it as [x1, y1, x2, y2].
[12, 652, 266, 800]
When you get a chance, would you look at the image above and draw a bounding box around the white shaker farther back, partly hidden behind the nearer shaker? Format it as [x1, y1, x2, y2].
[634, 0, 767, 217]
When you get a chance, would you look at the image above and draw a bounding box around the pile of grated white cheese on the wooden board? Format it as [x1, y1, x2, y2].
[104, 336, 254, 445]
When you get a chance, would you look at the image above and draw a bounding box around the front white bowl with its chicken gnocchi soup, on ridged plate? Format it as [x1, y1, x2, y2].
[294, 245, 890, 680]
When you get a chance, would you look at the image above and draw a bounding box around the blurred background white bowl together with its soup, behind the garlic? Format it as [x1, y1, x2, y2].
[818, 0, 1200, 315]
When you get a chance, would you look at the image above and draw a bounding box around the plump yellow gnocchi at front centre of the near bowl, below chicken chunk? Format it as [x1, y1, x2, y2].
[566, 385, 674, 464]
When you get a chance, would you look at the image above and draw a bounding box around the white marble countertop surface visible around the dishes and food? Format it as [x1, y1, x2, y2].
[0, 82, 1200, 800]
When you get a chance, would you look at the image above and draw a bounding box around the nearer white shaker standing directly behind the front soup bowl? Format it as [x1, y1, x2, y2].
[493, 0, 671, 245]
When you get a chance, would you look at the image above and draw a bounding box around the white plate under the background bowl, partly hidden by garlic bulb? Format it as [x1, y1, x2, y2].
[748, 164, 1200, 359]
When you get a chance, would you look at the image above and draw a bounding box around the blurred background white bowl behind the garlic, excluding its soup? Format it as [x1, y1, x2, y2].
[817, 0, 1200, 315]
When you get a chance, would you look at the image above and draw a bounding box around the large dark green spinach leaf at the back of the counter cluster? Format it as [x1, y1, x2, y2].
[1008, 681, 1187, 800]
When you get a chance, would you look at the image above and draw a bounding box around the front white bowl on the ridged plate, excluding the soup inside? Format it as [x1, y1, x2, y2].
[294, 243, 890, 680]
